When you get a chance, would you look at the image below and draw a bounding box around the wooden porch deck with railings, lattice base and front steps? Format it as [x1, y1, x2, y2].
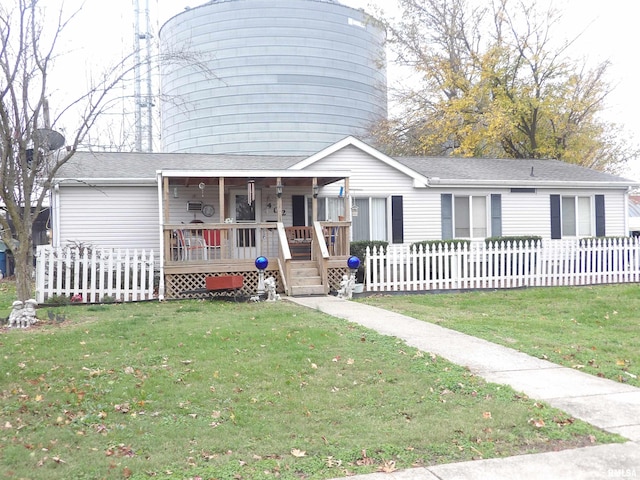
[163, 222, 350, 298]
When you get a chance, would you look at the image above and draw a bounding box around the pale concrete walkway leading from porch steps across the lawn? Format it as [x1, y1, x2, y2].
[288, 297, 640, 480]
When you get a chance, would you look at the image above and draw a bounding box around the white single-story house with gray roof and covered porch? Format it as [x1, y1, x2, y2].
[51, 137, 637, 297]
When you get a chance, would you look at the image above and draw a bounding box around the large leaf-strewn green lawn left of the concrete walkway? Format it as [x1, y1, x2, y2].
[0, 284, 622, 480]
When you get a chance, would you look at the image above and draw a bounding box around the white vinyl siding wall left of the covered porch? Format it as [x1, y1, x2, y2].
[54, 185, 160, 252]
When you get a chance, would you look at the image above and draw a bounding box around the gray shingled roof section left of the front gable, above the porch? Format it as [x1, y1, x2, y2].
[57, 152, 305, 180]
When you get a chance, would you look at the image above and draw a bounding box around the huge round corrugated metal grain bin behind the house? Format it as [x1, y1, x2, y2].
[160, 0, 387, 155]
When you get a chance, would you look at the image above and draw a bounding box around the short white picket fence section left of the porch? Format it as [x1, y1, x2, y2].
[36, 246, 155, 303]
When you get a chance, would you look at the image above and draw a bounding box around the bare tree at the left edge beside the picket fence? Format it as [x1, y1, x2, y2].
[0, 0, 205, 301]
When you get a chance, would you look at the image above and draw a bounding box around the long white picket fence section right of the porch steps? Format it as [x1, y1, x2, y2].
[365, 238, 640, 292]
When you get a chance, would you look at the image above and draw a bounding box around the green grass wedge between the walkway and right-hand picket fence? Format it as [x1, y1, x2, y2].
[362, 284, 640, 386]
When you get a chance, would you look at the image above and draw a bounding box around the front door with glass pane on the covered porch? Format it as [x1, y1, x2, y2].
[231, 190, 260, 258]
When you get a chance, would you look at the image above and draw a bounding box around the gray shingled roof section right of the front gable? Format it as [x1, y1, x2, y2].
[394, 157, 636, 184]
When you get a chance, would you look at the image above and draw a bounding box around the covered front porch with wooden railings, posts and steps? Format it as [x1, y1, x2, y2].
[158, 170, 351, 298]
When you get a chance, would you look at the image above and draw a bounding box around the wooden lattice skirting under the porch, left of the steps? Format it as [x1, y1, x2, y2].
[165, 270, 282, 299]
